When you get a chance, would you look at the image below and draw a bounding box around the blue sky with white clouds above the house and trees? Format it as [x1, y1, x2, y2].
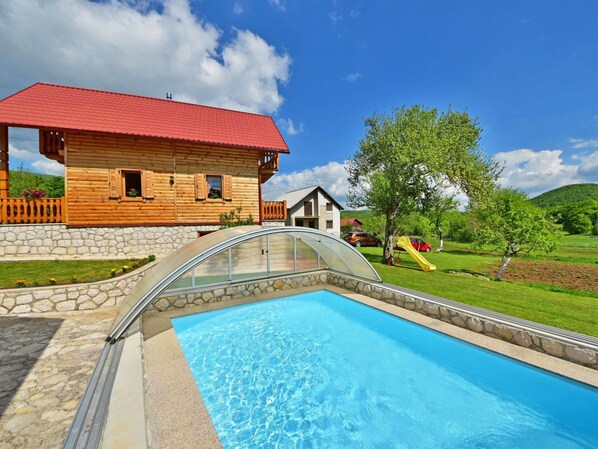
[0, 0, 598, 204]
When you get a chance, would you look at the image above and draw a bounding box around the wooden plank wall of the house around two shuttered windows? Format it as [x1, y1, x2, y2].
[65, 131, 259, 226]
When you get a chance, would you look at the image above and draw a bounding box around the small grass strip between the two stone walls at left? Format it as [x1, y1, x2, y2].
[0, 259, 149, 288]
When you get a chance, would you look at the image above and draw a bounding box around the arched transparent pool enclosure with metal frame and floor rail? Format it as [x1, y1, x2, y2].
[63, 226, 382, 449]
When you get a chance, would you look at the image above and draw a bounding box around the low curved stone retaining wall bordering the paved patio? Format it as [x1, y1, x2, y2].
[0, 262, 155, 315]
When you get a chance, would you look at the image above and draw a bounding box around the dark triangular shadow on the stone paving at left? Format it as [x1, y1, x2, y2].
[0, 316, 63, 416]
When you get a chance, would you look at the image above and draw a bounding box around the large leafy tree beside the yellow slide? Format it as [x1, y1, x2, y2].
[347, 106, 497, 259]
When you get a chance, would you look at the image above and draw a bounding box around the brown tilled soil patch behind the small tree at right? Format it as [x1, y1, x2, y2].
[493, 260, 598, 292]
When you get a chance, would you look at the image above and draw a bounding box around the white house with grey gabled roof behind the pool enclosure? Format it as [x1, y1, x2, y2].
[277, 186, 343, 237]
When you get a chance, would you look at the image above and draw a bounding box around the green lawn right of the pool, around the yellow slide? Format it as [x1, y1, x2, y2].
[360, 248, 598, 337]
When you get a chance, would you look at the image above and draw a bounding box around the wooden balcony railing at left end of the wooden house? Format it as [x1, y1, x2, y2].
[0, 197, 66, 224]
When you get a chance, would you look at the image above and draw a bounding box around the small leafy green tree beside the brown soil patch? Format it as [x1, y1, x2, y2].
[473, 189, 561, 281]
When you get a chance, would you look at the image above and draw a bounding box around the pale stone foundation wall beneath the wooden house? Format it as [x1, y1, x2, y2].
[0, 224, 217, 260]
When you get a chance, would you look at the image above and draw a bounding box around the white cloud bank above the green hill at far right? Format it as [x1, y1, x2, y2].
[493, 149, 598, 197]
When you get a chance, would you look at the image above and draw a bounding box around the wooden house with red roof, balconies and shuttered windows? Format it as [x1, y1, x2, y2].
[0, 83, 289, 227]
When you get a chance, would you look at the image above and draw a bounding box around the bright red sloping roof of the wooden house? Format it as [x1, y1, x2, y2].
[0, 83, 289, 153]
